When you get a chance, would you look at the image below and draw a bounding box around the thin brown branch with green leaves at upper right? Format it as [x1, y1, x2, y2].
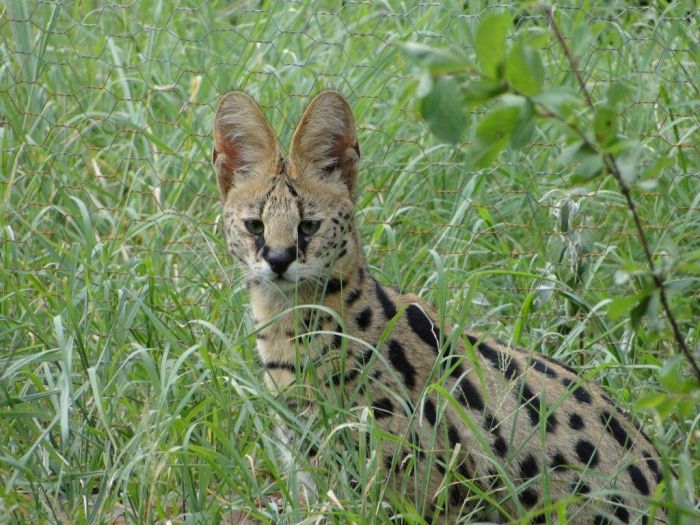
[404, 6, 700, 382]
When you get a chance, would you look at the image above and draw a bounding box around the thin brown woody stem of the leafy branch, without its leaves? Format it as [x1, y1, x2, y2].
[543, 5, 700, 381]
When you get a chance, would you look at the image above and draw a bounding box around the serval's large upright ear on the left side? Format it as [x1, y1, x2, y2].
[212, 91, 279, 199]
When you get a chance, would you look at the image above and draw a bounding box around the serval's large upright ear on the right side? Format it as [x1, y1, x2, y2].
[288, 91, 360, 201]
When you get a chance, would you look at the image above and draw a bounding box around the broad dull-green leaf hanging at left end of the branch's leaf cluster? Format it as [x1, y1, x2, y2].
[420, 77, 467, 144]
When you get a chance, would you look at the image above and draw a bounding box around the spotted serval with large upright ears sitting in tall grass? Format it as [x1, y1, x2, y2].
[213, 91, 665, 524]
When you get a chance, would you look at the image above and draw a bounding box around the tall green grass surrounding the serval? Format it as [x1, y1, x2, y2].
[0, 0, 700, 523]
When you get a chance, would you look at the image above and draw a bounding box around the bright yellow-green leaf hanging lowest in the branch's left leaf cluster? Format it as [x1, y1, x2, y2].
[468, 105, 520, 169]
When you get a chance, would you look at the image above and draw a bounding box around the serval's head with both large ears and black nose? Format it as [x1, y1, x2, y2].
[212, 91, 362, 290]
